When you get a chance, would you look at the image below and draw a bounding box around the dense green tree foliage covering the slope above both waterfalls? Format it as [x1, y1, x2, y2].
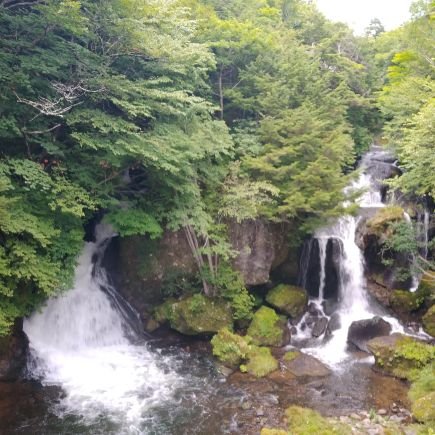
[0, 0, 434, 334]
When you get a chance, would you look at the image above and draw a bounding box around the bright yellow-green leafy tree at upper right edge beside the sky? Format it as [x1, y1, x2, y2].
[378, 1, 435, 198]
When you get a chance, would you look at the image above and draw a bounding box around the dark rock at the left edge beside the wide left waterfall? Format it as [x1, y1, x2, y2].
[0, 320, 29, 381]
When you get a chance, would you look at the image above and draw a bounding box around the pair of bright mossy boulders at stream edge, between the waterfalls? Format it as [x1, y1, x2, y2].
[211, 328, 278, 377]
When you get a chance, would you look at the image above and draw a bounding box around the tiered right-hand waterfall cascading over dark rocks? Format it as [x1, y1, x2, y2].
[293, 146, 410, 367]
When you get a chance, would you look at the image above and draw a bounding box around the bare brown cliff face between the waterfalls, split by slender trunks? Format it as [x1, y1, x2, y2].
[104, 220, 298, 315]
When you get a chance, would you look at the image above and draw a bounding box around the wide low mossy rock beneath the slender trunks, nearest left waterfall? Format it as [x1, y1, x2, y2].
[154, 294, 232, 335]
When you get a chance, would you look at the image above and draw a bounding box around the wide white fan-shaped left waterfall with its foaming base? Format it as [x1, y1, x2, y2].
[24, 226, 180, 433]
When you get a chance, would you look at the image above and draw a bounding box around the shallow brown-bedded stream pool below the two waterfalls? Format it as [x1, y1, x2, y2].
[0, 339, 408, 435]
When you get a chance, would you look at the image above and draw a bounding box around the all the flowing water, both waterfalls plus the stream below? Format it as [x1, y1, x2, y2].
[0, 147, 430, 435]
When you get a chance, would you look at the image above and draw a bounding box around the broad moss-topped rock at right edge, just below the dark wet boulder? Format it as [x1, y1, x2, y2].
[367, 334, 435, 379]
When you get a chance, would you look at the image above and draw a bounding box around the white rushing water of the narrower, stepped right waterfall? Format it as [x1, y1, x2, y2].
[296, 147, 410, 367]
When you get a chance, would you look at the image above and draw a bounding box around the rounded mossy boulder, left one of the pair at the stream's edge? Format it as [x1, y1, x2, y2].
[211, 328, 250, 368]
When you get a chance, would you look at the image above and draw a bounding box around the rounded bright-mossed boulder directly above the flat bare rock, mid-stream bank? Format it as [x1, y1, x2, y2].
[247, 306, 290, 346]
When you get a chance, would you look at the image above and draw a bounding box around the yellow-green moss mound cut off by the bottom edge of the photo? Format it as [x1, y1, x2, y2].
[285, 406, 352, 435]
